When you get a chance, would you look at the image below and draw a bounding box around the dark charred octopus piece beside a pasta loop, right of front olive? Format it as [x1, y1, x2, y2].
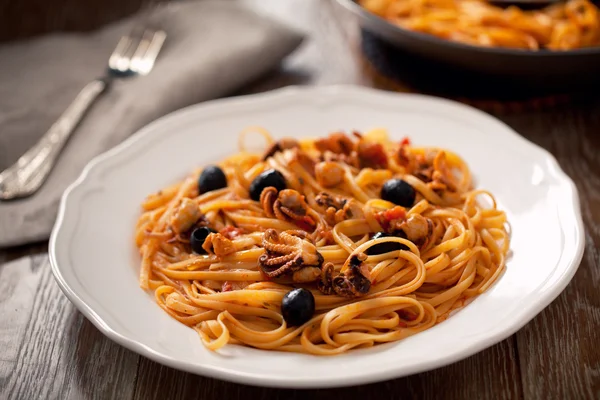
[317, 253, 371, 297]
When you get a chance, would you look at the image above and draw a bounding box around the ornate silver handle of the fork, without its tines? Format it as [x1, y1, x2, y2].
[0, 78, 109, 200]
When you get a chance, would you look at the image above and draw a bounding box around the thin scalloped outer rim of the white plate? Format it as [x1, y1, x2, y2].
[49, 85, 585, 388]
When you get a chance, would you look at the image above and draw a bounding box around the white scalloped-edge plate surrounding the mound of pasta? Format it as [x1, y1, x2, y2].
[50, 87, 584, 387]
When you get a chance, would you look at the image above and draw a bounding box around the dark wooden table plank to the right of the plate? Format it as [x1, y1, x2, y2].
[505, 102, 600, 399]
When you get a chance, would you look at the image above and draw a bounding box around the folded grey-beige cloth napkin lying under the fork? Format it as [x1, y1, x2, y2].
[0, 1, 302, 247]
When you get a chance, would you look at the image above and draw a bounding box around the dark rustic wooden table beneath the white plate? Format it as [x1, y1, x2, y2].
[0, 0, 600, 400]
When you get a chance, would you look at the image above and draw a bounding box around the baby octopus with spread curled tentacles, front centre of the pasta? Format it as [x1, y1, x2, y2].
[258, 229, 323, 283]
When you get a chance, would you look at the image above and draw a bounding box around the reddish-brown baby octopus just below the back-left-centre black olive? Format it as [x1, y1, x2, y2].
[260, 187, 316, 230]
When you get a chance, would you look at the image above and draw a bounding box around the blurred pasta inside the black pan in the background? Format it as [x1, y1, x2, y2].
[360, 0, 600, 50]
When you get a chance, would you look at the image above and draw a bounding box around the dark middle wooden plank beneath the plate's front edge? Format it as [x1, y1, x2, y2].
[134, 340, 522, 400]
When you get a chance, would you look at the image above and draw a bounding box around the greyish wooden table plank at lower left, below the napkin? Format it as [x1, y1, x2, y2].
[0, 254, 140, 399]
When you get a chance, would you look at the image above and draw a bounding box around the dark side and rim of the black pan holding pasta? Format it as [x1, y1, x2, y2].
[338, 0, 600, 92]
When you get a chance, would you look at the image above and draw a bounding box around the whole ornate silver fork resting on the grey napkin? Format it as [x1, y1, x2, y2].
[0, 28, 167, 200]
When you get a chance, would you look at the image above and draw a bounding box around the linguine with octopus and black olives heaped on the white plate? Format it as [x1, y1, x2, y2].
[135, 128, 509, 355]
